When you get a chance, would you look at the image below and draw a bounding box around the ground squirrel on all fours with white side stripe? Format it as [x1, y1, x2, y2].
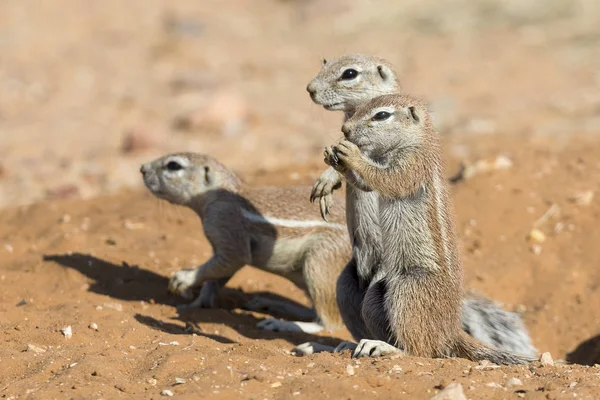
[141, 153, 350, 333]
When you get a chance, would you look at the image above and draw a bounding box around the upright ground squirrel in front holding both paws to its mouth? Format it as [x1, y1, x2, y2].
[326, 94, 535, 364]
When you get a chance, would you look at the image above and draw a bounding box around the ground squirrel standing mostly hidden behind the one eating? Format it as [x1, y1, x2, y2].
[298, 54, 537, 356]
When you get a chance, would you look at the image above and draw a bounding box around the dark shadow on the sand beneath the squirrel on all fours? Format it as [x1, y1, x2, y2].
[43, 253, 340, 346]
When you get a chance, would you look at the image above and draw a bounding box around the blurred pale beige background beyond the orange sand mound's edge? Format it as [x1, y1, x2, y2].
[0, 0, 600, 206]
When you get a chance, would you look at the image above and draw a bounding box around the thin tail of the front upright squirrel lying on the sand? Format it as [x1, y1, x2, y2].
[454, 330, 537, 365]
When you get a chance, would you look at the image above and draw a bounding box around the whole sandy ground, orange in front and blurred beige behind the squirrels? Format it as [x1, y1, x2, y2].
[0, 0, 600, 399]
